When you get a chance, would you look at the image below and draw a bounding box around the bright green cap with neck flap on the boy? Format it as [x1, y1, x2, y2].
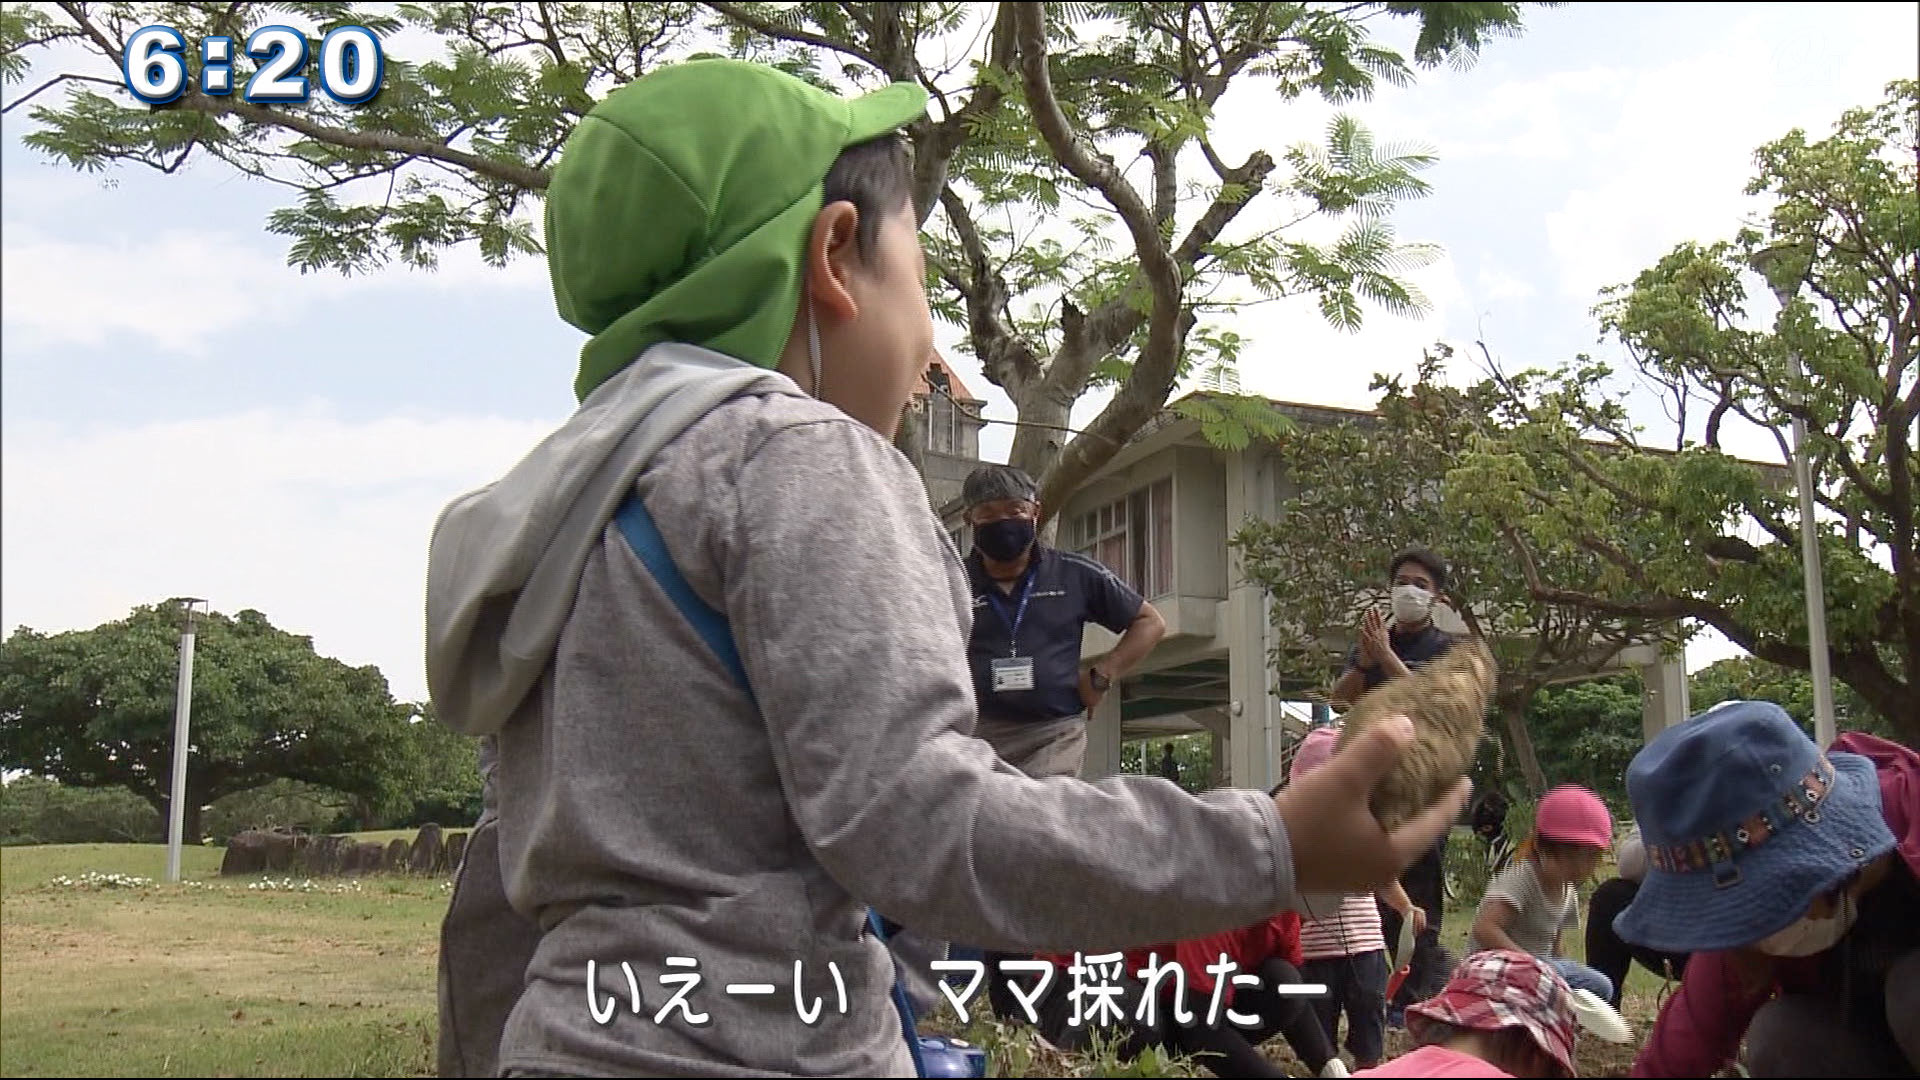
[547, 60, 927, 402]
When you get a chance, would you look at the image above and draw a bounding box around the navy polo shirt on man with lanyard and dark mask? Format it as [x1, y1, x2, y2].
[966, 544, 1146, 721]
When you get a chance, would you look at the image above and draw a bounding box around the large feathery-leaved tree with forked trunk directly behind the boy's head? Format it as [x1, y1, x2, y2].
[0, 2, 1543, 507]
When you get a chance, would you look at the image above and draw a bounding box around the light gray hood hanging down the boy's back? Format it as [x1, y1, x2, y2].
[426, 342, 804, 736]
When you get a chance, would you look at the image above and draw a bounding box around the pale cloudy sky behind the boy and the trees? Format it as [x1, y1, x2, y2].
[0, 4, 1920, 700]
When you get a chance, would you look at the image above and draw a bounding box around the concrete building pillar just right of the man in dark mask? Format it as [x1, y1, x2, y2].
[1225, 452, 1281, 790]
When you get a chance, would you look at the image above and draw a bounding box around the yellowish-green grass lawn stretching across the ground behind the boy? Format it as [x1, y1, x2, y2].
[0, 830, 1661, 1076]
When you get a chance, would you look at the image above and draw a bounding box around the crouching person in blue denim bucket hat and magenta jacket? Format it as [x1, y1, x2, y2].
[1613, 701, 1920, 1076]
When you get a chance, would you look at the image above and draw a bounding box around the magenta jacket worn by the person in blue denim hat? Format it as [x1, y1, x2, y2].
[1632, 732, 1920, 1076]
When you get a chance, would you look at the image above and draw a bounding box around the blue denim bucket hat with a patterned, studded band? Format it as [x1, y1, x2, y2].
[1613, 701, 1893, 953]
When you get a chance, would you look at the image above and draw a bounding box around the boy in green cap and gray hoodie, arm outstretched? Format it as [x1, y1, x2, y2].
[426, 60, 1465, 1076]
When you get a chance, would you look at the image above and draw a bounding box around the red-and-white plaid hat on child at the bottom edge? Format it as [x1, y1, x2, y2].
[1407, 949, 1576, 1076]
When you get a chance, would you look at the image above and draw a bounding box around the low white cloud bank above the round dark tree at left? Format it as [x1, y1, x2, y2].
[0, 407, 559, 700]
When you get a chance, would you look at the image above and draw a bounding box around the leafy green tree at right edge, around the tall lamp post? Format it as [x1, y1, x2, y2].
[1448, 81, 1920, 744]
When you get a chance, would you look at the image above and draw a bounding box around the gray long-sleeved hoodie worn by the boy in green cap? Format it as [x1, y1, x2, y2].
[426, 346, 1296, 1076]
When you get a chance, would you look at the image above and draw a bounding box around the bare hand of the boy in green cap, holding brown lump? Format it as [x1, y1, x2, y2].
[1273, 717, 1473, 892]
